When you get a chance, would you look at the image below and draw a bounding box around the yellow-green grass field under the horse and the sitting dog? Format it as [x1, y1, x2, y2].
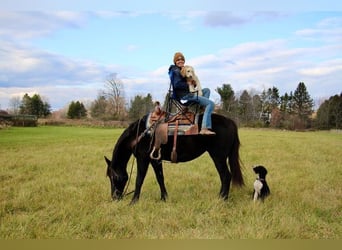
[0, 126, 342, 239]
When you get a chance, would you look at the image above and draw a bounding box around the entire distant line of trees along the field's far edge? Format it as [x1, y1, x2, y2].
[6, 74, 342, 130]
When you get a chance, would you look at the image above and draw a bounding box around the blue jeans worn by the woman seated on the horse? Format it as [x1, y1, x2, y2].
[181, 88, 215, 128]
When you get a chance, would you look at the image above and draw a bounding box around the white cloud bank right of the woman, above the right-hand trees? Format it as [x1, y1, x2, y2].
[189, 32, 342, 100]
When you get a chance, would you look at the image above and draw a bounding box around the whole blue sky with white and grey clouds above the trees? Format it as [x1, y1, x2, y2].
[0, 0, 342, 110]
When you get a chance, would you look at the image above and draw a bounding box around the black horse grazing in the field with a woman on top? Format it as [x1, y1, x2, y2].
[105, 114, 244, 203]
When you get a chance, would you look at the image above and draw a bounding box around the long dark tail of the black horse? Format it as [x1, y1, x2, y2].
[229, 124, 245, 186]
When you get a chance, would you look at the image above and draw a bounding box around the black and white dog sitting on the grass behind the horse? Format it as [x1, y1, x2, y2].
[253, 165, 271, 202]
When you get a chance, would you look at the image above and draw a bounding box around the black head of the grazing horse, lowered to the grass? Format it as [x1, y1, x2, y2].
[105, 157, 128, 200]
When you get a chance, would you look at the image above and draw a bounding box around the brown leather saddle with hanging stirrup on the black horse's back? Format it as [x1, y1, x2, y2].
[146, 109, 199, 163]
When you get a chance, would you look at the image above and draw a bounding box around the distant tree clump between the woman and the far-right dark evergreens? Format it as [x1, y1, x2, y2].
[216, 82, 313, 129]
